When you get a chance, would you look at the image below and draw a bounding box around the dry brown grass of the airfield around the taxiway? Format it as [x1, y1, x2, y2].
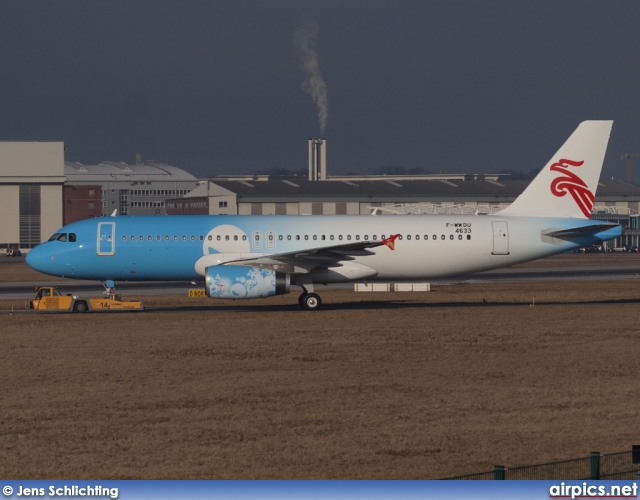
[0, 254, 640, 479]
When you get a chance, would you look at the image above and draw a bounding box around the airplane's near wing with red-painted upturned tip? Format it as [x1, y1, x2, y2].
[223, 234, 399, 272]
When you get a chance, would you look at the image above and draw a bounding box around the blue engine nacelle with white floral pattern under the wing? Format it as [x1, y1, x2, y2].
[204, 266, 290, 299]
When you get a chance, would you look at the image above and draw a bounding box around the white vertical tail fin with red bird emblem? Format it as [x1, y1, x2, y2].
[500, 120, 613, 219]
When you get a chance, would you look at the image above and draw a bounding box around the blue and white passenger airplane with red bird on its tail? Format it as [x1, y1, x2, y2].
[26, 120, 622, 311]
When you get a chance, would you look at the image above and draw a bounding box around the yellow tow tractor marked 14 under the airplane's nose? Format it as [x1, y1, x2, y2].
[29, 286, 144, 312]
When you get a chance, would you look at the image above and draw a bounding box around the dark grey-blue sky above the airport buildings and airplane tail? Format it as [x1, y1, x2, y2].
[0, 0, 640, 181]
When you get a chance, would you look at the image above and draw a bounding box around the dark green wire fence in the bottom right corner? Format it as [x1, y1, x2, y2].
[443, 445, 640, 480]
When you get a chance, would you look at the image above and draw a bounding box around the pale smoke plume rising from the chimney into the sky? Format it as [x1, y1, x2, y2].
[294, 20, 329, 136]
